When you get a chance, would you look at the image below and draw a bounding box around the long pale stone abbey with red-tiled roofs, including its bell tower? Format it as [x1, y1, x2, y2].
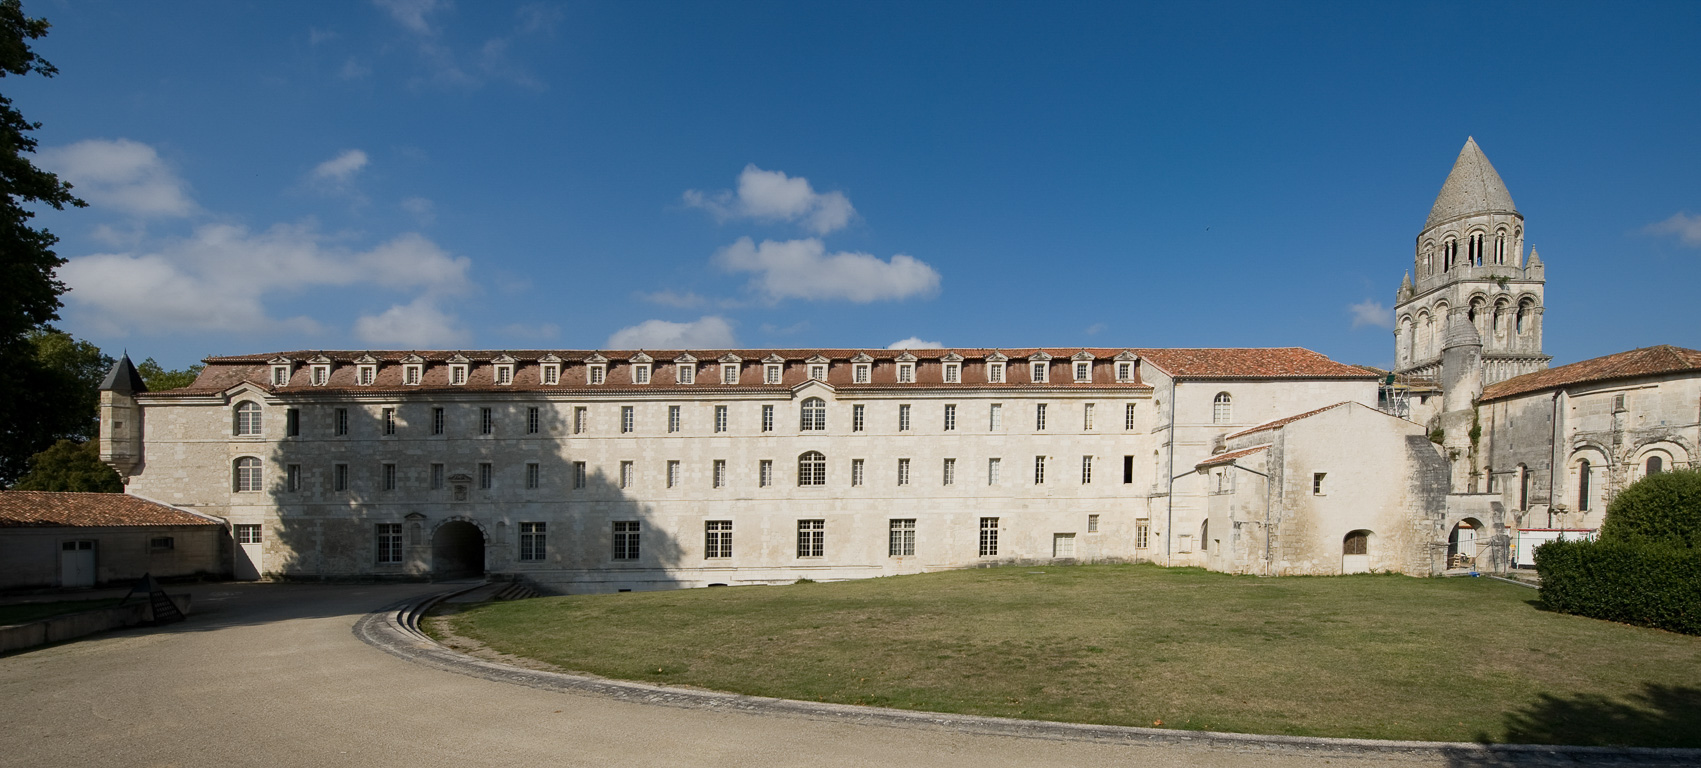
[100, 141, 1701, 591]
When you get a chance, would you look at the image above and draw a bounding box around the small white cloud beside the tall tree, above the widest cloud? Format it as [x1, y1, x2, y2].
[39, 138, 197, 216]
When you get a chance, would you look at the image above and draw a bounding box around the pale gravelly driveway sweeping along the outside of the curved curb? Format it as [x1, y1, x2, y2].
[0, 584, 1673, 766]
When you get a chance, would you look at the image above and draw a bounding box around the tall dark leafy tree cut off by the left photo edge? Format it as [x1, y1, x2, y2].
[0, 0, 88, 485]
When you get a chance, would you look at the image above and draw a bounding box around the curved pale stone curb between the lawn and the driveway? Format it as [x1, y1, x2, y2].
[352, 586, 1701, 768]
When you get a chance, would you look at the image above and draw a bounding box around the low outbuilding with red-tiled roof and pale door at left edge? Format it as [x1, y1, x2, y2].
[0, 490, 230, 589]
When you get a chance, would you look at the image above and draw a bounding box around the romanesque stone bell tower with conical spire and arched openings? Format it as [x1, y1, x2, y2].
[1395, 138, 1551, 487]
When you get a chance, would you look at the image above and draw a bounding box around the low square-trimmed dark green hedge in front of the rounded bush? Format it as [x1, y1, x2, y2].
[1536, 540, 1701, 635]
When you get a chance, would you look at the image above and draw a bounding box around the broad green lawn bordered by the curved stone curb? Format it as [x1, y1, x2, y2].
[446, 565, 1701, 746]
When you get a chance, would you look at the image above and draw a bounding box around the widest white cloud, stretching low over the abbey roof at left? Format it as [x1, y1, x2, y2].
[58, 225, 471, 335]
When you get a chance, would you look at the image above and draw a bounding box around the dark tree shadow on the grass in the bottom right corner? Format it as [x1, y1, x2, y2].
[1448, 683, 1701, 768]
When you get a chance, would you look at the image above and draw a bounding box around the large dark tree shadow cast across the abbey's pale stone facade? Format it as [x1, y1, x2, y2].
[260, 393, 684, 593]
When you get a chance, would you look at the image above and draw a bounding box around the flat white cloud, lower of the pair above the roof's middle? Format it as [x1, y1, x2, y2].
[714, 237, 939, 303]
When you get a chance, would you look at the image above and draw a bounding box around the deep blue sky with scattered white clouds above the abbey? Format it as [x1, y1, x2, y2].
[5, 0, 1701, 366]
